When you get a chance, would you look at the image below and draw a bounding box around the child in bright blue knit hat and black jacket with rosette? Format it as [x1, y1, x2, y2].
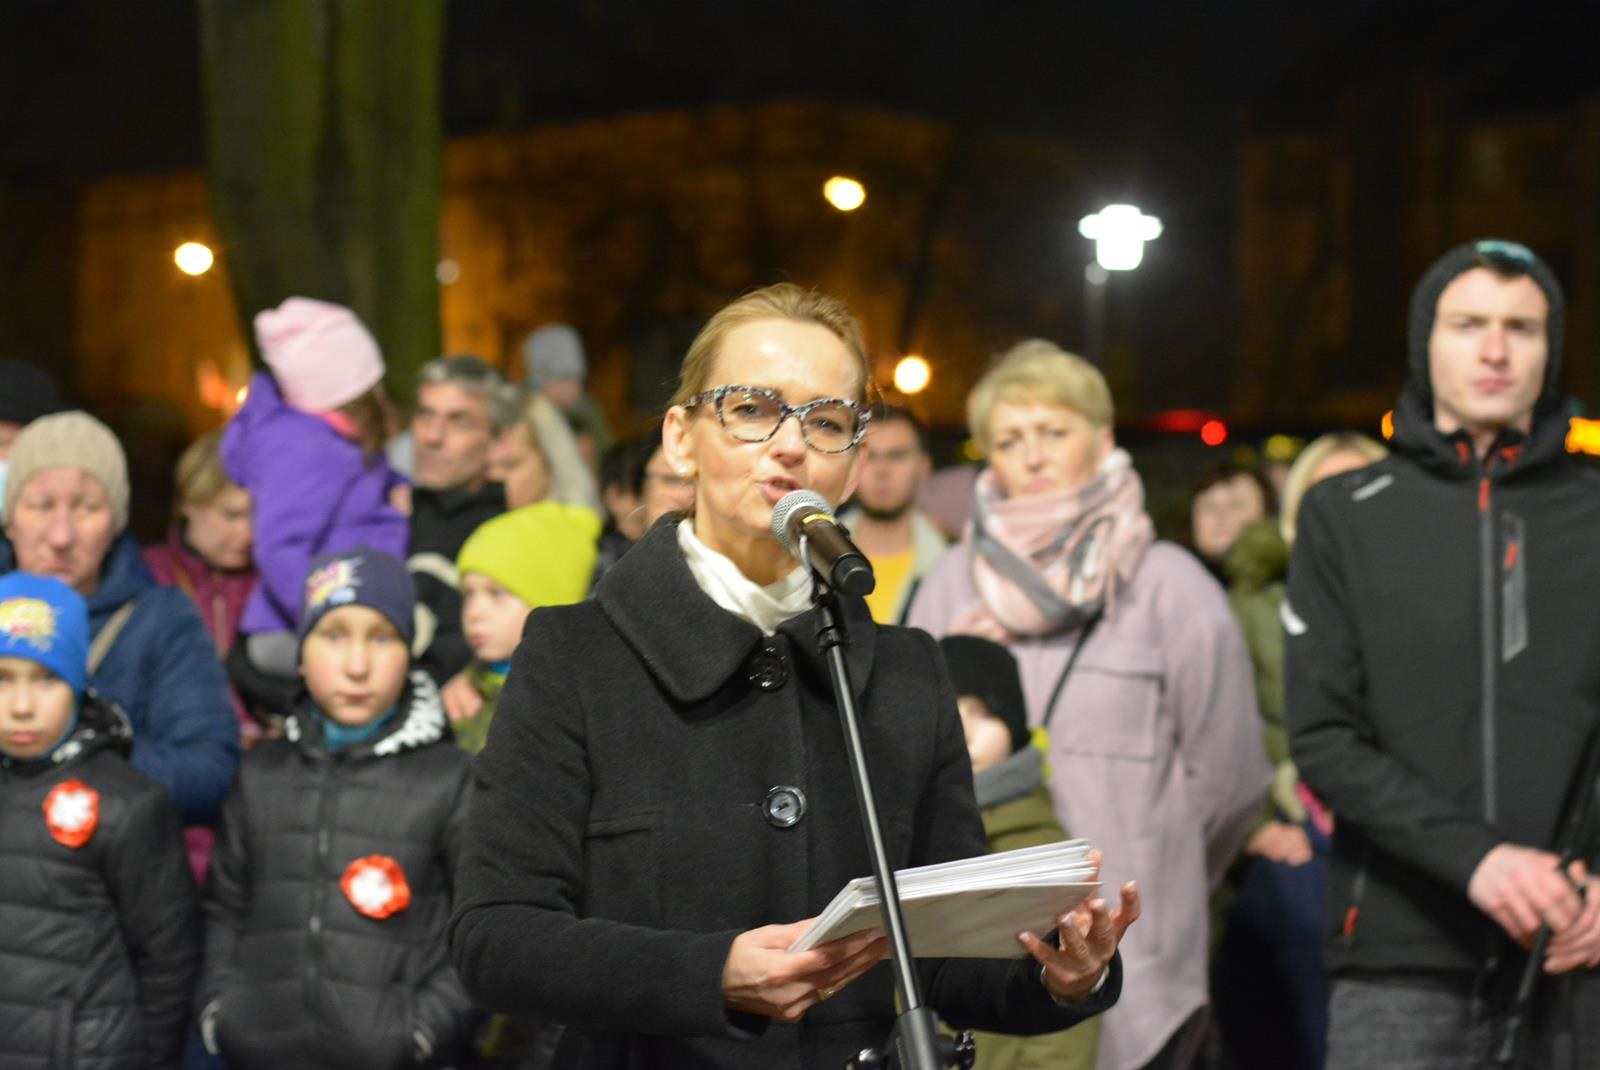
[0, 573, 200, 1067]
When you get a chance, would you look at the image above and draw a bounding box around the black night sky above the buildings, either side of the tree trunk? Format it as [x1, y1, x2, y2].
[0, 0, 1381, 182]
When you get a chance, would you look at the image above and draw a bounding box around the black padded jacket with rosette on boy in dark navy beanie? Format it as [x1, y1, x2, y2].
[195, 672, 475, 1070]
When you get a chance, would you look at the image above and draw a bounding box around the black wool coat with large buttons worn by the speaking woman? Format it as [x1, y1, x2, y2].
[451, 523, 1120, 1070]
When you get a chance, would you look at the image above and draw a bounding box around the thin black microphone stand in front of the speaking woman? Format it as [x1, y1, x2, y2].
[812, 556, 976, 1070]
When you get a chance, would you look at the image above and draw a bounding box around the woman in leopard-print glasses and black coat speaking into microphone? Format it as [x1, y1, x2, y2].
[451, 285, 1138, 1070]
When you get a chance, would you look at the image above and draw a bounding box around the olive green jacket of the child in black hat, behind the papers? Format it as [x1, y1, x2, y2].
[974, 747, 1101, 1070]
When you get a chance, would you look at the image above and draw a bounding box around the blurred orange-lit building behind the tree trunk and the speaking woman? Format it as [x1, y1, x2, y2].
[72, 101, 1080, 433]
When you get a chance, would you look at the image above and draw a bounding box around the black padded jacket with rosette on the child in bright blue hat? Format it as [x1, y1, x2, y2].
[0, 694, 200, 1070]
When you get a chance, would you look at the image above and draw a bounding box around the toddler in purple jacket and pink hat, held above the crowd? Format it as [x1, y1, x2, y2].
[222, 297, 410, 677]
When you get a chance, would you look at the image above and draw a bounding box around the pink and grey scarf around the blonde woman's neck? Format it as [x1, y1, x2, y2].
[950, 449, 1155, 643]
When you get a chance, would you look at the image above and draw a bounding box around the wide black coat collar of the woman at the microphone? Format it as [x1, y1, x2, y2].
[595, 517, 877, 704]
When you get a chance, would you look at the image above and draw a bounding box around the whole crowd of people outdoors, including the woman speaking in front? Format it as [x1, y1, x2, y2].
[0, 242, 1600, 1070]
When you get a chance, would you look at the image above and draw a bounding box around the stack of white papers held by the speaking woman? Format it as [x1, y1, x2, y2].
[789, 840, 1099, 958]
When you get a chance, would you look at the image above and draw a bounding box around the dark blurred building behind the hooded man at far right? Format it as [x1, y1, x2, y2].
[1230, 35, 1600, 427]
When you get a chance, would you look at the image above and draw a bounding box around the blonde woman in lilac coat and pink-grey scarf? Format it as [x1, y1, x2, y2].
[907, 341, 1270, 1070]
